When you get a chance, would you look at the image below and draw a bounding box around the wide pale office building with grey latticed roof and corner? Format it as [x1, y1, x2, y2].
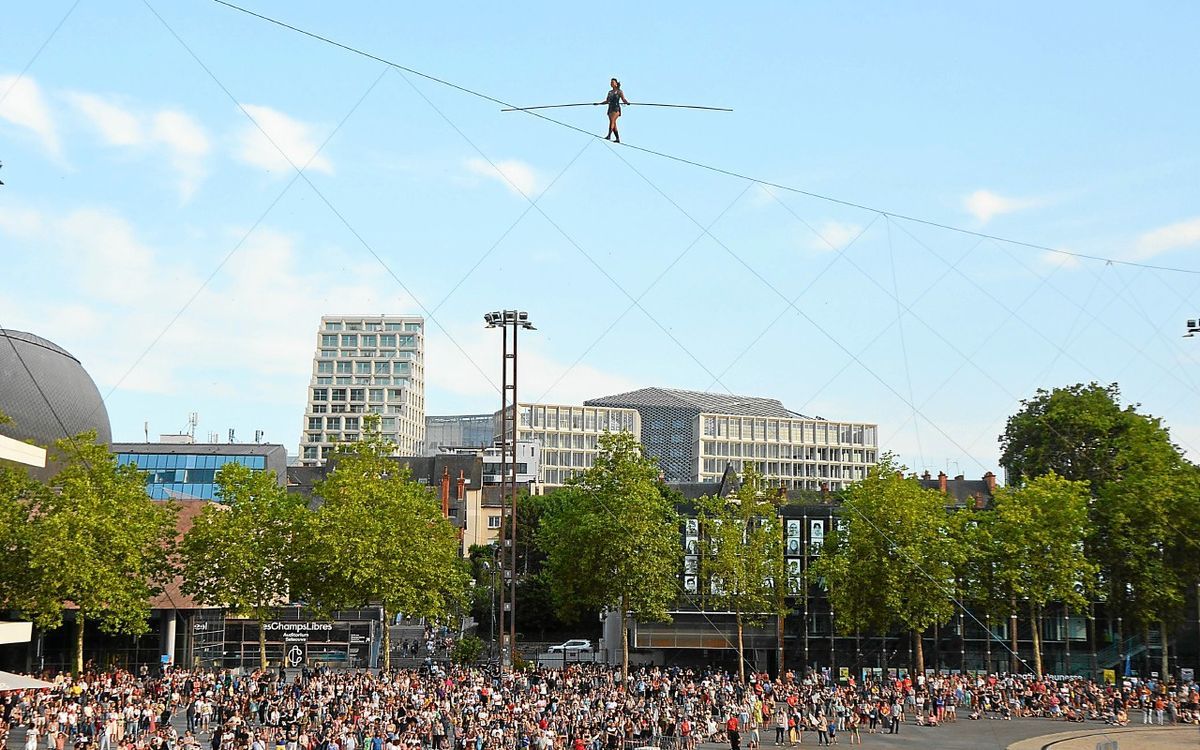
[584, 388, 878, 491]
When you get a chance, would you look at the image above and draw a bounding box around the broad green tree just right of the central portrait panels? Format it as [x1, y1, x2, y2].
[811, 455, 962, 674]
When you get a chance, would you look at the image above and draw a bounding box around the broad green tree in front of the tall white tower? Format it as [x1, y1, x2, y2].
[298, 414, 468, 670]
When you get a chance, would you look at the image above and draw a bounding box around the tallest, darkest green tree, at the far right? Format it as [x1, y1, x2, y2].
[1001, 383, 1200, 664]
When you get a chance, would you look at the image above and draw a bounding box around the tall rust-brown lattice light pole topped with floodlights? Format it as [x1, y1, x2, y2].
[484, 310, 536, 667]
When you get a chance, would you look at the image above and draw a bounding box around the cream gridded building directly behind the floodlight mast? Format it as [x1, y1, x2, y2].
[493, 403, 641, 486]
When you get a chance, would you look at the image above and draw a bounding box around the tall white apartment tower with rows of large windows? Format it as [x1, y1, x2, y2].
[300, 316, 425, 466]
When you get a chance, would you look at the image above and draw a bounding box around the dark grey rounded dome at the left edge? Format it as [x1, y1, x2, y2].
[0, 329, 113, 448]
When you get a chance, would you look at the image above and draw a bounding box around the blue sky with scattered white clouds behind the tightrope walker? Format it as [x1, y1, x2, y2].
[0, 0, 1200, 476]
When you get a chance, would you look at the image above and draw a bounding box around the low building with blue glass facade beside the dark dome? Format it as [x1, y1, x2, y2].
[110, 443, 288, 500]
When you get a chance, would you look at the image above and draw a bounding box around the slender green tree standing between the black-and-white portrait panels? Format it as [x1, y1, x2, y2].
[697, 462, 787, 683]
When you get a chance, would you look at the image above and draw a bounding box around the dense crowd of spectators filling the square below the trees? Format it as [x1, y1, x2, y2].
[0, 665, 1200, 750]
